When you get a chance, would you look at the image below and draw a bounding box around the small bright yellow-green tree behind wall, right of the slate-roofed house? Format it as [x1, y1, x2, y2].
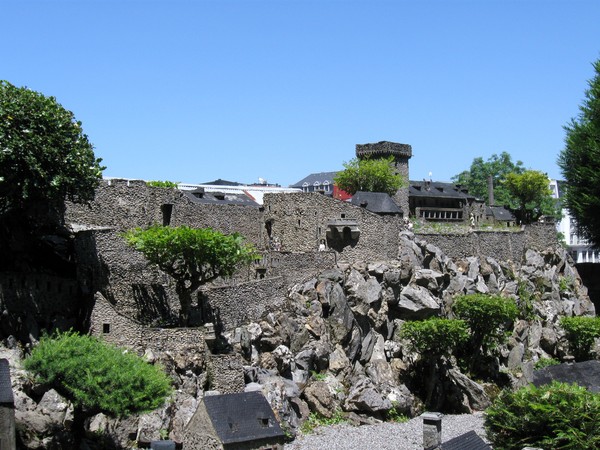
[504, 170, 560, 223]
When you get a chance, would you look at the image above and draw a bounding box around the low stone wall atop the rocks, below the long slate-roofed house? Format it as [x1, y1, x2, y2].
[415, 223, 560, 263]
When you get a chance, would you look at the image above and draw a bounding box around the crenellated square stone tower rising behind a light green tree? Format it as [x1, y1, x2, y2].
[356, 141, 412, 217]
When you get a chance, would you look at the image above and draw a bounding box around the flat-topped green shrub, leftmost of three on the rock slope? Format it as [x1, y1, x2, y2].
[398, 317, 469, 358]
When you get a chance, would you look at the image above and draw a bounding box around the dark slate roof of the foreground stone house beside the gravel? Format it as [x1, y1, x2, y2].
[204, 392, 284, 444]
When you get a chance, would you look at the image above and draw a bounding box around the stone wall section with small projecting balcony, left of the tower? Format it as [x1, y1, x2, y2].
[264, 193, 403, 261]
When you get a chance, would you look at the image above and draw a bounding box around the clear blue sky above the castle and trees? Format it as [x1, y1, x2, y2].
[0, 0, 600, 186]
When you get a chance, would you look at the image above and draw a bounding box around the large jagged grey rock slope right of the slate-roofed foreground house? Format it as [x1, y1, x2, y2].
[230, 233, 594, 423]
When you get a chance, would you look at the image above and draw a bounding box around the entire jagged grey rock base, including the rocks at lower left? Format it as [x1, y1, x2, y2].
[5, 232, 595, 448]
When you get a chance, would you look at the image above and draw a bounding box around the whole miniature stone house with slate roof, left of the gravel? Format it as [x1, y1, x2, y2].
[183, 392, 285, 450]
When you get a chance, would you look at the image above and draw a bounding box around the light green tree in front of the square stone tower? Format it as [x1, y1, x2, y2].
[333, 156, 403, 195]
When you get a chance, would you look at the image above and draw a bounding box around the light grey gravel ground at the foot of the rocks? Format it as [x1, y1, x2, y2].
[284, 412, 485, 450]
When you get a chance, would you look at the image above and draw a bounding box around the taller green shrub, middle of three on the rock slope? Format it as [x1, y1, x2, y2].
[452, 294, 519, 355]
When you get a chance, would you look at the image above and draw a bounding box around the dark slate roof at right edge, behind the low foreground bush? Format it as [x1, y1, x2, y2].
[533, 360, 600, 392]
